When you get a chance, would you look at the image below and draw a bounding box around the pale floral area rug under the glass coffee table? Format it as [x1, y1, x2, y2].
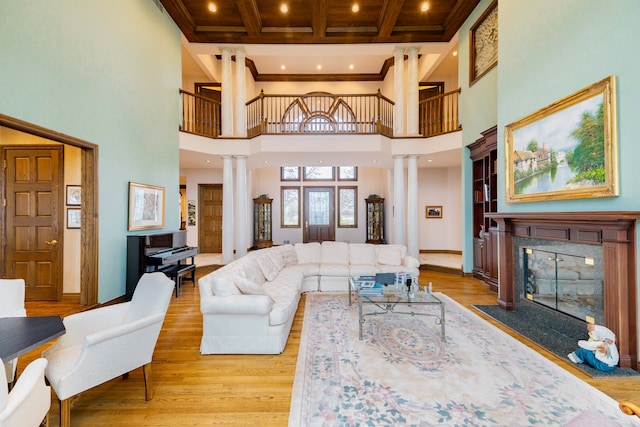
[289, 293, 640, 427]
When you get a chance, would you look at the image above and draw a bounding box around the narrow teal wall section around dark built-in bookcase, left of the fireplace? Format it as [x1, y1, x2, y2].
[458, 0, 498, 273]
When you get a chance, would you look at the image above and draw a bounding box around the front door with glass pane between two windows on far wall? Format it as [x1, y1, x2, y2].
[302, 187, 336, 243]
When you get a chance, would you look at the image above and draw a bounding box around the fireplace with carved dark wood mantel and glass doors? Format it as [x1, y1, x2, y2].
[487, 212, 640, 369]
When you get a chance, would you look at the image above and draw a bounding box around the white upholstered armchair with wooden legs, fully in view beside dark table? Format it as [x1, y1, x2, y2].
[43, 273, 174, 427]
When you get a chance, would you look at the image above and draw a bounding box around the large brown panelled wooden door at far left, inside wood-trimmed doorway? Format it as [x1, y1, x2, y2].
[3, 146, 63, 301]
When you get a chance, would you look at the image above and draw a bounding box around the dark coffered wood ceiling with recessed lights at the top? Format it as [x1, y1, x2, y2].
[159, 0, 480, 44]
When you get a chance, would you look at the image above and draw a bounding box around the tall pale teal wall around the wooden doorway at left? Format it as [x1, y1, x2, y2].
[0, 0, 182, 302]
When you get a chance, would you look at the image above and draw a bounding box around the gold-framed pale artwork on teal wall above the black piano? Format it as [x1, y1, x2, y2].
[129, 182, 164, 230]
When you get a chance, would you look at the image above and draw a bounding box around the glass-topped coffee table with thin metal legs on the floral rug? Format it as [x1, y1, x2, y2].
[349, 278, 445, 342]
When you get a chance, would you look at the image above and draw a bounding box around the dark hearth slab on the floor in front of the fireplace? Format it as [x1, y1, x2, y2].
[473, 305, 640, 377]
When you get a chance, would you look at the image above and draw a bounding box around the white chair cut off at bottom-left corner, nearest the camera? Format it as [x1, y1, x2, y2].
[0, 358, 51, 427]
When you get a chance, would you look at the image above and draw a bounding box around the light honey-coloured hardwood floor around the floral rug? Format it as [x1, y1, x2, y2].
[18, 271, 640, 427]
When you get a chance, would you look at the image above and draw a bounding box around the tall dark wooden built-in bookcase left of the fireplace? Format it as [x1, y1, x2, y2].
[468, 126, 498, 292]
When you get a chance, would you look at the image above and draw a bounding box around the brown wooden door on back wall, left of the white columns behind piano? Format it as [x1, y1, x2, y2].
[198, 184, 222, 253]
